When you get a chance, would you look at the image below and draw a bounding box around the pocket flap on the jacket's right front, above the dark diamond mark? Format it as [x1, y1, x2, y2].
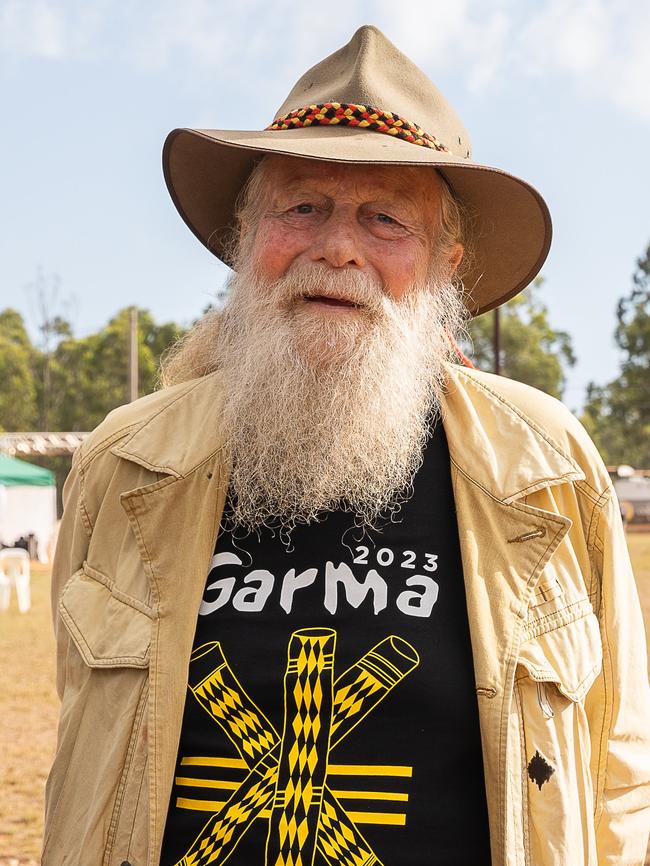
[517, 613, 602, 701]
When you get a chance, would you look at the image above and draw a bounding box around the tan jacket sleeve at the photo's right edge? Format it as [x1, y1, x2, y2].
[590, 488, 650, 866]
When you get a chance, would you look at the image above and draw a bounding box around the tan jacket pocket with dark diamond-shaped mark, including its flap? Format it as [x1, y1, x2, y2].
[513, 603, 602, 866]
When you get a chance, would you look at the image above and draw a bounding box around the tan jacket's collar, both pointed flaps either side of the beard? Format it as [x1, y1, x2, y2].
[113, 364, 585, 504]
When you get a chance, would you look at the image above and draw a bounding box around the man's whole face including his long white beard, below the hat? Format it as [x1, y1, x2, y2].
[215, 157, 466, 531]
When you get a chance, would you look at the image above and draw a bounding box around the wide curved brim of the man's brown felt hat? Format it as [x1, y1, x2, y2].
[163, 126, 552, 316]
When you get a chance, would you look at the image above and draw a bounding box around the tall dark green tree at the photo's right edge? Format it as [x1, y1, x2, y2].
[582, 245, 650, 469]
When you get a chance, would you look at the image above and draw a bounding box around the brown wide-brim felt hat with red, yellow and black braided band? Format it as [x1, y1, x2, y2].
[163, 26, 551, 315]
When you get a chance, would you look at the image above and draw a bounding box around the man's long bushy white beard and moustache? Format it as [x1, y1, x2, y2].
[218, 266, 467, 531]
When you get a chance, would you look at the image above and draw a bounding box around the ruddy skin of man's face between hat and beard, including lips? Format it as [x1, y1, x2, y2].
[244, 156, 462, 308]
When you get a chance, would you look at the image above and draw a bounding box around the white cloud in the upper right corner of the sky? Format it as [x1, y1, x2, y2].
[374, 0, 650, 122]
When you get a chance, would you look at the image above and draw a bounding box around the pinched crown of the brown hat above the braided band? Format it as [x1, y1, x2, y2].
[275, 25, 472, 159]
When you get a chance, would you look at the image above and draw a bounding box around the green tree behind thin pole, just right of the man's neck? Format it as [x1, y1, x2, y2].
[463, 277, 575, 398]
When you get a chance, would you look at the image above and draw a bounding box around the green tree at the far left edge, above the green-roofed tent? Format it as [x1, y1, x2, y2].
[0, 308, 38, 431]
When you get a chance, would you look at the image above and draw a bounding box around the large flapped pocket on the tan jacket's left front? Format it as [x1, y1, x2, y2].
[42, 563, 157, 866]
